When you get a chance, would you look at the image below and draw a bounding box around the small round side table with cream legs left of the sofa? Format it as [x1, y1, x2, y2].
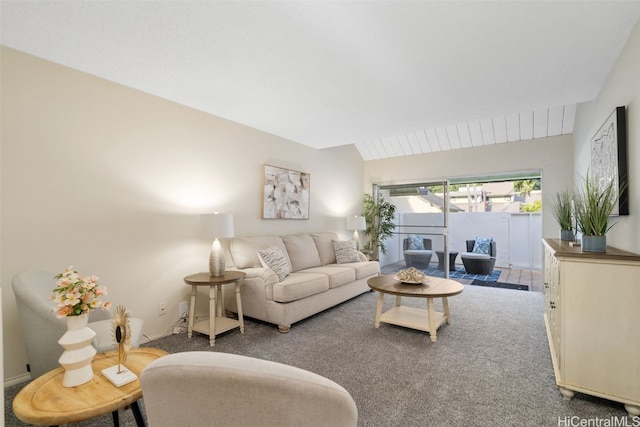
[184, 271, 246, 347]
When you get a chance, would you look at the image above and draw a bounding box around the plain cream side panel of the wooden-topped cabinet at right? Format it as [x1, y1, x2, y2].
[560, 261, 640, 402]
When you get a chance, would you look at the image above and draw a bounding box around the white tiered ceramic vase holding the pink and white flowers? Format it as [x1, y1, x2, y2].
[58, 314, 96, 387]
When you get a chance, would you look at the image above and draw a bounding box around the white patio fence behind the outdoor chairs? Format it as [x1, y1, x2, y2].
[380, 212, 542, 270]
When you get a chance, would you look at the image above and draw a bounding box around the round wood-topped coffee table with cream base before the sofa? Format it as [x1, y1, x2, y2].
[367, 275, 464, 342]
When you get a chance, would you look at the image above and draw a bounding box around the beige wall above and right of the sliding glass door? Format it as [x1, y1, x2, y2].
[364, 135, 573, 241]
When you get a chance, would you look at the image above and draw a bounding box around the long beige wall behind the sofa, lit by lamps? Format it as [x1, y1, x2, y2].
[0, 47, 363, 381]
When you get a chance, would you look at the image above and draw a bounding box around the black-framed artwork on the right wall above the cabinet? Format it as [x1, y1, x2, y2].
[589, 107, 629, 215]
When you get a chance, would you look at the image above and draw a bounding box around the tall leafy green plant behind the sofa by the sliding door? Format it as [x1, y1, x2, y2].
[362, 194, 396, 261]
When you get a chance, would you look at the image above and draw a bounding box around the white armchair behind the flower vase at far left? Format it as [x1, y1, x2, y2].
[12, 271, 143, 378]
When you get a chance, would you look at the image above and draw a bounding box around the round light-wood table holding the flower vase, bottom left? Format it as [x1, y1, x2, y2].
[13, 348, 168, 426]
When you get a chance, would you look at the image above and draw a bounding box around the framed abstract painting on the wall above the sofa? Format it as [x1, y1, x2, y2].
[262, 165, 311, 219]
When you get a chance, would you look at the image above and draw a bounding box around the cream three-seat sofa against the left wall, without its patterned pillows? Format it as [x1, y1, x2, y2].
[223, 233, 380, 332]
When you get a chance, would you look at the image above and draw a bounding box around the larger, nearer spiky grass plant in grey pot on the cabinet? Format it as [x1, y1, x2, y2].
[576, 174, 619, 252]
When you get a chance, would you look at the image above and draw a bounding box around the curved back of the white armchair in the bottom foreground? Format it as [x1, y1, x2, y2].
[140, 351, 358, 427]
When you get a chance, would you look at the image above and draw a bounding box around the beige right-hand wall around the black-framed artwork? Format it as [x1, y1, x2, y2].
[573, 22, 640, 253]
